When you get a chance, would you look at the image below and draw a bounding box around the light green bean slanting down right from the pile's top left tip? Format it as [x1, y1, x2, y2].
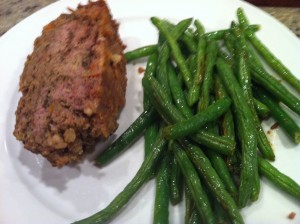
[151, 17, 192, 88]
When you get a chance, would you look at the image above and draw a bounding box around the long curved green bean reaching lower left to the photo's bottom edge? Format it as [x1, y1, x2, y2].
[74, 133, 166, 224]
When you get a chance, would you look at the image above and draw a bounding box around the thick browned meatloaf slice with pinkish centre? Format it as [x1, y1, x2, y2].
[14, 0, 127, 167]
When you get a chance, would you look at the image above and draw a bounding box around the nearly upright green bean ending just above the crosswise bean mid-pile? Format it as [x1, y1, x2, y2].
[198, 41, 219, 112]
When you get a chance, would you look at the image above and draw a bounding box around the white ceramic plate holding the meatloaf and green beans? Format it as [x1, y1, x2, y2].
[0, 0, 300, 224]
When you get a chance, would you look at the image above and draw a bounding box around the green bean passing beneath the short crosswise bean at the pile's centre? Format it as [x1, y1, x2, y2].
[142, 74, 235, 155]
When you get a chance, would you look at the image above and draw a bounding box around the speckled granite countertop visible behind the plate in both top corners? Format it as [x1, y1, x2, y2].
[0, 0, 300, 37]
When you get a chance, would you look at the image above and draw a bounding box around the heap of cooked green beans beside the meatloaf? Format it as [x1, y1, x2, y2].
[75, 8, 300, 223]
